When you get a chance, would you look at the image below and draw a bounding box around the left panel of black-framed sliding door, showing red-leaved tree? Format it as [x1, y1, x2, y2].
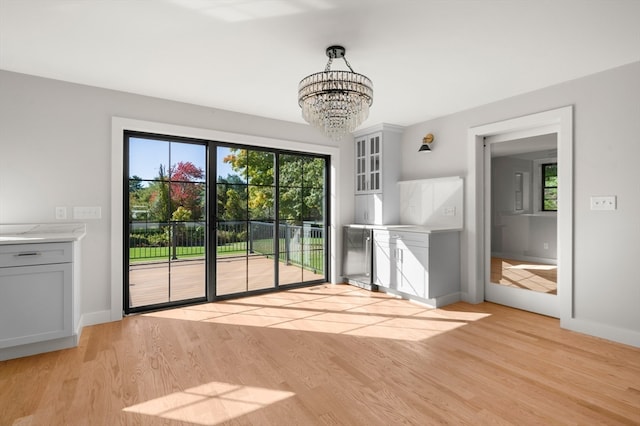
[129, 134, 207, 313]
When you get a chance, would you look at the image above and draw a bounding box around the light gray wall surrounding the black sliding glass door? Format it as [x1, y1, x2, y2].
[0, 70, 353, 323]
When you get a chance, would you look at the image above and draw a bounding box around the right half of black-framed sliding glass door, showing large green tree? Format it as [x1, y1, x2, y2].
[216, 146, 327, 296]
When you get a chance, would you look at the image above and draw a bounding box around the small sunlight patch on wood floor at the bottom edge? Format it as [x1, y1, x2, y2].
[123, 382, 295, 425]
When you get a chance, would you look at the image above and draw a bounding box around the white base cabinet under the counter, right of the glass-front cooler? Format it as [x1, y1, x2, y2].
[373, 230, 460, 307]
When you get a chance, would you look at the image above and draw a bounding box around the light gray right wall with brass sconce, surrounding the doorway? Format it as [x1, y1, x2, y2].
[401, 62, 640, 346]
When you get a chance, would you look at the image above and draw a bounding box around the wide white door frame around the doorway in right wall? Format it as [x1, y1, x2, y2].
[463, 106, 573, 319]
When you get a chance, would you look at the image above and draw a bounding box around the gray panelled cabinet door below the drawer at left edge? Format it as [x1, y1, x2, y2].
[0, 263, 73, 348]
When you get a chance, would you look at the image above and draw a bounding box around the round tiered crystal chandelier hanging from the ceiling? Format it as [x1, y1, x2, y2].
[298, 46, 373, 140]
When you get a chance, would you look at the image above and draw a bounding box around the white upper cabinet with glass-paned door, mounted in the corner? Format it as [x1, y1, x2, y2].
[354, 124, 402, 225]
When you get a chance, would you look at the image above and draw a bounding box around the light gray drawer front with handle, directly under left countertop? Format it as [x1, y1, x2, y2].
[0, 242, 73, 268]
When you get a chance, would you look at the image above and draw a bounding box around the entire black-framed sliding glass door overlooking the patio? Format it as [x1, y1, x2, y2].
[123, 132, 328, 313]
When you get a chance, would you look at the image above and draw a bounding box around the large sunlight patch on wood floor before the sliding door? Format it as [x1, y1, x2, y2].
[144, 286, 489, 341]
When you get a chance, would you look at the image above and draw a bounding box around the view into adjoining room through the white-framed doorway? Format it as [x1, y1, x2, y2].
[485, 133, 558, 295]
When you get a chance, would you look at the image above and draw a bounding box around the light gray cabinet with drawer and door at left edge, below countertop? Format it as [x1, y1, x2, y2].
[0, 242, 78, 359]
